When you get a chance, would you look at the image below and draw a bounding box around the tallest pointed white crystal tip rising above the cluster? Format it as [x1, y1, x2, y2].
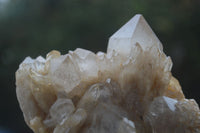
[107, 14, 163, 55]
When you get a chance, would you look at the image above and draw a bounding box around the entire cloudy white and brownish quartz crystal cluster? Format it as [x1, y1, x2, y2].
[16, 15, 200, 133]
